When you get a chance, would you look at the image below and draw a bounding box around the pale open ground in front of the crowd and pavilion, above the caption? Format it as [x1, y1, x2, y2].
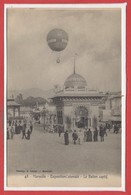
[7, 127, 121, 175]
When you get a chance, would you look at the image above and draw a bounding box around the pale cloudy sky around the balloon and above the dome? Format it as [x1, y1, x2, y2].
[7, 8, 121, 91]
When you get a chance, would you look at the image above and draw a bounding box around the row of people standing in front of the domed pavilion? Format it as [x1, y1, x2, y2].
[64, 126, 107, 145]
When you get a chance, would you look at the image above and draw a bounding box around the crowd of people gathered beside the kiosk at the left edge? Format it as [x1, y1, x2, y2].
[7, 119, 33, 140]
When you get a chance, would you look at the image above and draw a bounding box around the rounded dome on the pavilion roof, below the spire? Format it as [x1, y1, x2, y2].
[64, 73, 87, 88]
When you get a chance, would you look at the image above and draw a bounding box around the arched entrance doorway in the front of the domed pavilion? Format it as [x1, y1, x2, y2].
[75, 106, 88, 128]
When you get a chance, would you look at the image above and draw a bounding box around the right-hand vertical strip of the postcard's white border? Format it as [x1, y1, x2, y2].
[121, 3, 126, 191]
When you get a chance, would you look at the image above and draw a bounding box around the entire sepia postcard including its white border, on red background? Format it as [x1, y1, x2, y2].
[4, 4, 126, 191]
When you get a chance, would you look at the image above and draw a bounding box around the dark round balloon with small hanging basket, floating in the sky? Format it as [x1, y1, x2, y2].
[47, 28, 68, 63]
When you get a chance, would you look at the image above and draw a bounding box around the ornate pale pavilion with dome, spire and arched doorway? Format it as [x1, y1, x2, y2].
[51, 65, 104, 130]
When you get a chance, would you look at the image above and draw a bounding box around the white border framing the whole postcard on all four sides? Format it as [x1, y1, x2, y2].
[4, 3, 127, 191]
